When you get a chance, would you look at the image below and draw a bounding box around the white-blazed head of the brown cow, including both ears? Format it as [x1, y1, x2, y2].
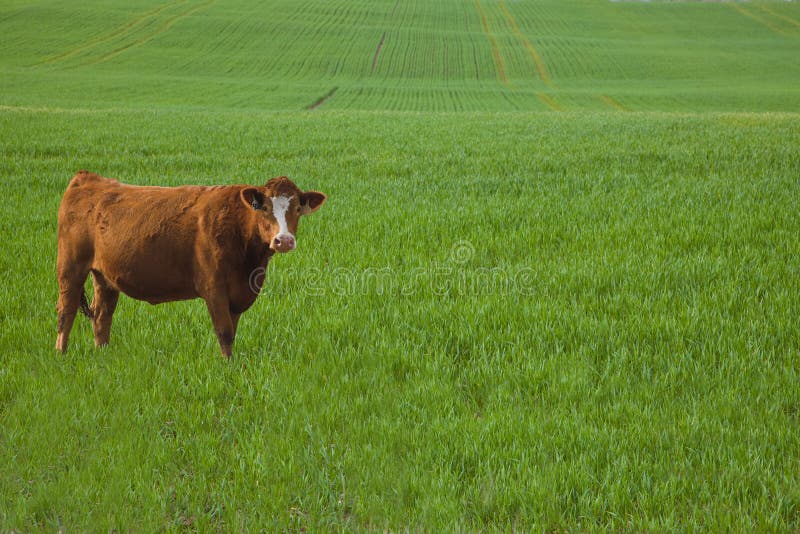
[241, 176, 327, 252]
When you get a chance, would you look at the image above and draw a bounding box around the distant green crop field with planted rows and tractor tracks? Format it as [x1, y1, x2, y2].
[0, 0, 800, 112]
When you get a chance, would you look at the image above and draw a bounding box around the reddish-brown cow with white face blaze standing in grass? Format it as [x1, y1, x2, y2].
[56, 171, 326, 357]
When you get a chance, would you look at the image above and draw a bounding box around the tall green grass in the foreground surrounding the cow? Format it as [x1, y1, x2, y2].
[0, 112, 800, 530]
